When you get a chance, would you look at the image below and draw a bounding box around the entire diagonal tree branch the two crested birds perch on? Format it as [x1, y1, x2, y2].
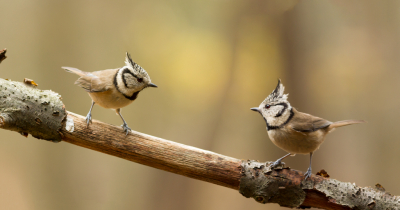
[0, 76, 400, 209]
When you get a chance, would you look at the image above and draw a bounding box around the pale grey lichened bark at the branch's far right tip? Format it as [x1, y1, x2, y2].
[315, 179, 400, 210]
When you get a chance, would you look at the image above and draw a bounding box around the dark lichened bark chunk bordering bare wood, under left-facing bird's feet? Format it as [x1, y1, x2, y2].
[239, 160, 306, 208]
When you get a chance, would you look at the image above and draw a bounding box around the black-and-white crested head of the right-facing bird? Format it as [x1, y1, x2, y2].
[114, 53, 155, 97]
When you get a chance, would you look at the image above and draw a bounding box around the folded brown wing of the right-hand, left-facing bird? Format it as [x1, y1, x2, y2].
[290, 109, 332, 132]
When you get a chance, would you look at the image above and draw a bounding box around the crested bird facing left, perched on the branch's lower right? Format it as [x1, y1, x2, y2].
[251, 80, 365, 179]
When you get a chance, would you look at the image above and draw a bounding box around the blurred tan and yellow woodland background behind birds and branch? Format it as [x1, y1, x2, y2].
[0, 0, 400, 210]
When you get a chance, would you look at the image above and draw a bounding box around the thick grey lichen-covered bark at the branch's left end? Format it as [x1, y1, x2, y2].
[0, 79, 66, 142]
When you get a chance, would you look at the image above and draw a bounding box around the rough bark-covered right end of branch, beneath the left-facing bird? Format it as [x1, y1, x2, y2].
[239, 161, 400, 210]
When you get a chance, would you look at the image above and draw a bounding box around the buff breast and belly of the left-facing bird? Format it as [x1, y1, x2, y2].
[268, 126, 326, 154]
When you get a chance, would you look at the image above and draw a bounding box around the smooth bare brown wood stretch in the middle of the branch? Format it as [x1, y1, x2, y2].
[62, 112, 241, 189]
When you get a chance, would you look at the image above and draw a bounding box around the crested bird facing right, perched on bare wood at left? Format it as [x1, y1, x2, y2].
[62, 52, 157, 135]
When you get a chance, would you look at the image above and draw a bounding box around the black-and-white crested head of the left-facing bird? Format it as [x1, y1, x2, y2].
[258, 80, 293, 130]
